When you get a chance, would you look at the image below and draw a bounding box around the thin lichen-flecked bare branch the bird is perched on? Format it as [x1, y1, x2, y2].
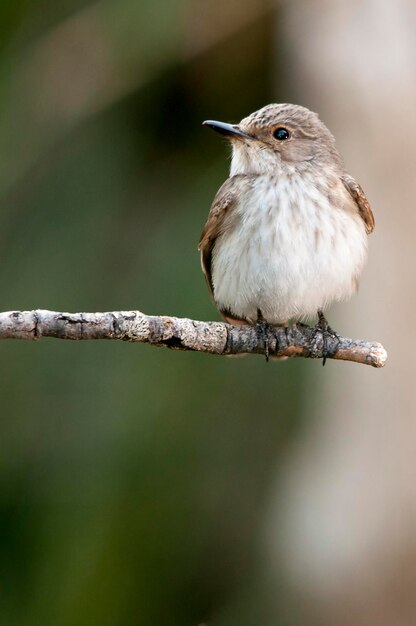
[0, 309, 387, 367]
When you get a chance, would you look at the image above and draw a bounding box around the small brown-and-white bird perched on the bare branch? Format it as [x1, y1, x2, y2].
[199, 104, 374, 358]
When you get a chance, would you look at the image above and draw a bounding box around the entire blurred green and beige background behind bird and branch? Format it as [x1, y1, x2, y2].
[0, 0, 416, 626]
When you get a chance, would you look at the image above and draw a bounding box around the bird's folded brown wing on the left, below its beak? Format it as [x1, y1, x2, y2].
[198, 176, 238, 299]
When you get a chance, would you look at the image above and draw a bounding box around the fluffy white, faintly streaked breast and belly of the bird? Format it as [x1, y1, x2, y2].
[212, 175, 367, 324]
